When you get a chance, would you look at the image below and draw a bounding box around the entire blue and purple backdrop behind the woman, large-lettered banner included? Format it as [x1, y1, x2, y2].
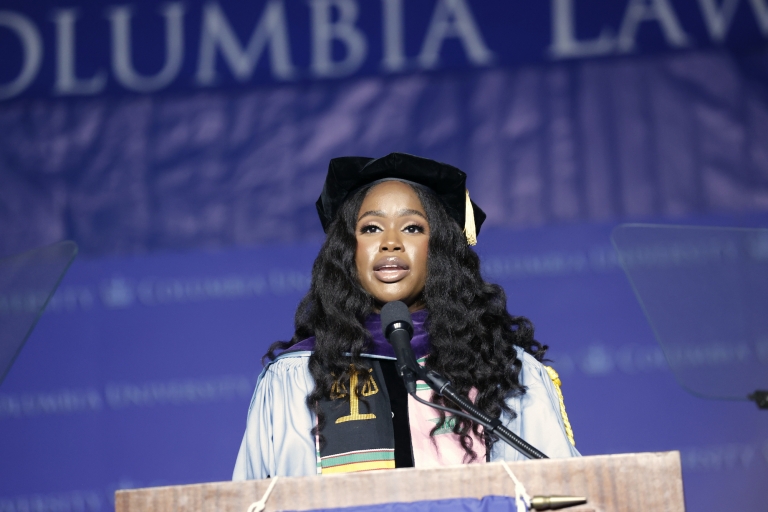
[0, 0, 768, 512]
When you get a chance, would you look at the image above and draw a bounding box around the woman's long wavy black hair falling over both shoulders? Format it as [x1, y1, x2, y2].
[264, 183, 547, 461]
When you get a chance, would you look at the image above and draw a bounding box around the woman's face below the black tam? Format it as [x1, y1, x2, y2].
[355, 181, 429, 311]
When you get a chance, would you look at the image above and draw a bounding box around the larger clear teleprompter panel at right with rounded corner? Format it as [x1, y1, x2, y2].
[611, 224, 768, 400]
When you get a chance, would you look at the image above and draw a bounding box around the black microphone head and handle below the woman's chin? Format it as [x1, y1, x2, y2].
[381, 300, 421, 395]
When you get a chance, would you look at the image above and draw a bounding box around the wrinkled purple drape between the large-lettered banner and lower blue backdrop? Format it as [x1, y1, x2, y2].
[0, 48, 768, 254]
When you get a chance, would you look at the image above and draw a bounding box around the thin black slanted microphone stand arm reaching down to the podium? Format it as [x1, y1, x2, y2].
[402, 361, 549, 459]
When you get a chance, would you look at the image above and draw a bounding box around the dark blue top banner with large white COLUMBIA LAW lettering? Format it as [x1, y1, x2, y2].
[0, 0, 768, 101]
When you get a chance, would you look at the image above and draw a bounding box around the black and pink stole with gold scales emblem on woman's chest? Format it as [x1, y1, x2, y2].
[317, 359, 485, 475]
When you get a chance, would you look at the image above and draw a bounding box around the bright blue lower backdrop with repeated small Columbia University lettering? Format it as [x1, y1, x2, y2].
[0, 218, 768, 512]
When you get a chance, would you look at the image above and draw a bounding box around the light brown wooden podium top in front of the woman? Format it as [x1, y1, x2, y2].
[115, 452, 685, 512]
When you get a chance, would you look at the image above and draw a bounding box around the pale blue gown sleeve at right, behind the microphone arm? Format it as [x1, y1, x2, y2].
[491, 350, 581, 461]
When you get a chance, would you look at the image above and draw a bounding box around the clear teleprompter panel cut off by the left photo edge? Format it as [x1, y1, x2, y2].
[0, 241, 77, 384]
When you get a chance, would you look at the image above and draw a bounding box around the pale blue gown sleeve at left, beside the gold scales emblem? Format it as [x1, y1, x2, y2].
[232, 355, 317, 480]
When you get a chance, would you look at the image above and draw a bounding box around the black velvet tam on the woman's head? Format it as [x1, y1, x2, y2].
[317, 153, 485, 233]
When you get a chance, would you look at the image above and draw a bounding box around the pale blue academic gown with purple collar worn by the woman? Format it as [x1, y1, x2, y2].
[232, 312, 580, 480]
